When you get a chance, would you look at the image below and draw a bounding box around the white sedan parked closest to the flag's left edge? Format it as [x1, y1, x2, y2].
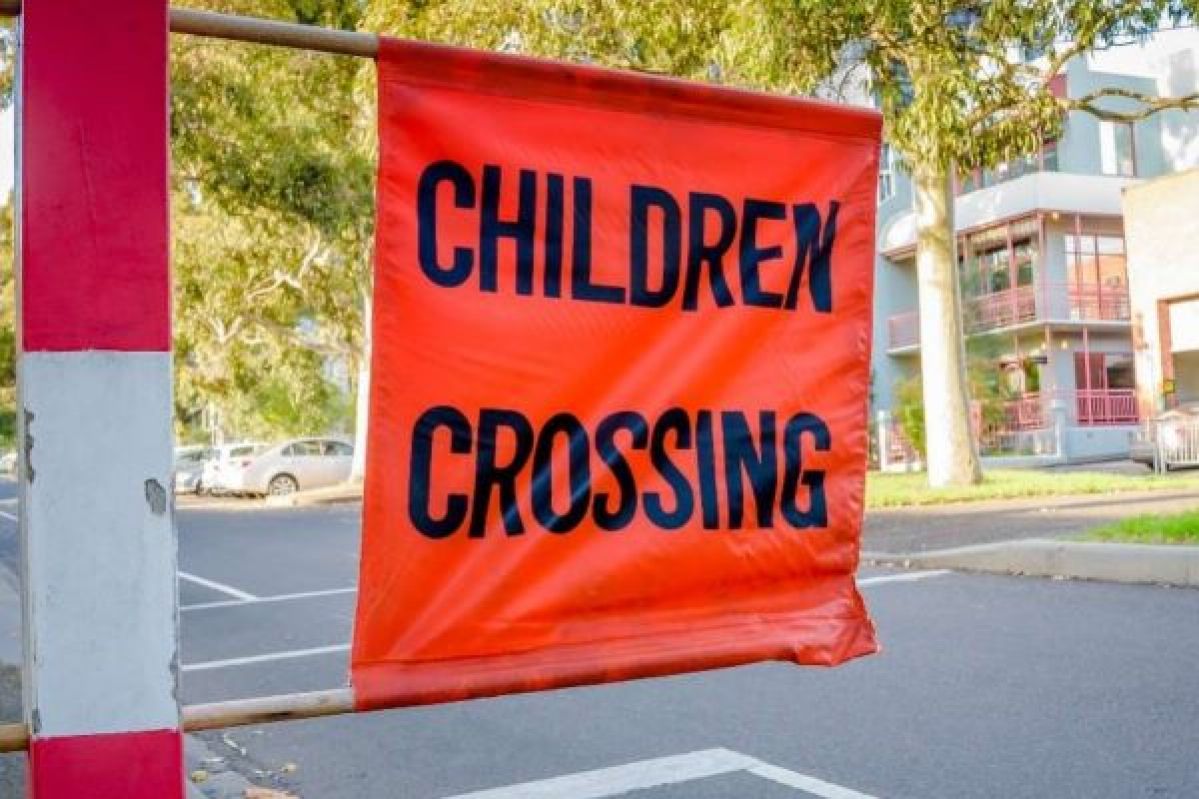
[221, 438, 354, 495]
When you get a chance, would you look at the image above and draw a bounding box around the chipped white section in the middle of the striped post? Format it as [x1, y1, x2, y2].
[18, 352, 179, 735]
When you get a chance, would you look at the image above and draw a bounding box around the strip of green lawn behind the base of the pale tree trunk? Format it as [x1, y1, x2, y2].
[866, 469, 1199, 507]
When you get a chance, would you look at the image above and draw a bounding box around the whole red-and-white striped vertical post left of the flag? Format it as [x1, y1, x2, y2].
[18, 0, 183, 799]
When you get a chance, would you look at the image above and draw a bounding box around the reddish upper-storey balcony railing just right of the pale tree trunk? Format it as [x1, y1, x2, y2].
[965, 281, 1131, 332]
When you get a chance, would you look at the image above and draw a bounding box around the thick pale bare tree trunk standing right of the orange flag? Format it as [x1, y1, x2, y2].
[912, 166, 982, 487]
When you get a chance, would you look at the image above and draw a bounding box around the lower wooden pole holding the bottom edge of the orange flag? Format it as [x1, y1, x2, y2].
[0, 687, 354, 753]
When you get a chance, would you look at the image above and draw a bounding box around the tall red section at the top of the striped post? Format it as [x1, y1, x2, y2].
[20, 0, 170, 352]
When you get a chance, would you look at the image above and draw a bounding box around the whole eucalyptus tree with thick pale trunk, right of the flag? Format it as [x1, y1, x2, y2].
[735, 0, 1199, 486]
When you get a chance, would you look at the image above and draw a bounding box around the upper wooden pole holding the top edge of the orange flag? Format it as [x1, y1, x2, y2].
[0, 0, 379, 59]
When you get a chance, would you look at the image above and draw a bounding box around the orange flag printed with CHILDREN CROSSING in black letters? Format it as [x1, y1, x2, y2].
[351, 40, 880, 708]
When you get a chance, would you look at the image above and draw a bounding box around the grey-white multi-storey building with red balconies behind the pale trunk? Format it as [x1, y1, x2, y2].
[872, 49, 1199, 462]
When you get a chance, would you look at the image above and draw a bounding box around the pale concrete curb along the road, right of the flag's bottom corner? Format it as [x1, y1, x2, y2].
[862, 539, 1199, 587]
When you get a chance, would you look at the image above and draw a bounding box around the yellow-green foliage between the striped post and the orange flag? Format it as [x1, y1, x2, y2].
[171, 0, 374, 438]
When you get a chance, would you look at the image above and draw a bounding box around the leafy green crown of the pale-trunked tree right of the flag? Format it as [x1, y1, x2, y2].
[746, 0, 1195, 173]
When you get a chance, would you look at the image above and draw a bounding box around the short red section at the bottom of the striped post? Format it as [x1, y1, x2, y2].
[26, 729, 183, 799]
